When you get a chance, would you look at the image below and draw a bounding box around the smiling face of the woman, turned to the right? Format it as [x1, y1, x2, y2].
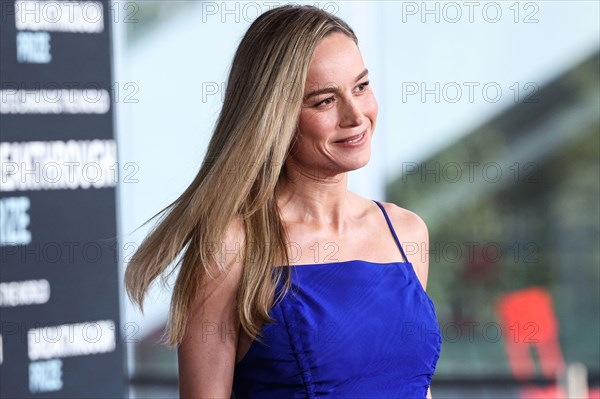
[288, 32, 377, 177]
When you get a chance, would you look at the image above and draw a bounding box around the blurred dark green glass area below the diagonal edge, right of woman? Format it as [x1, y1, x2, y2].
[388, 53, 600, 381]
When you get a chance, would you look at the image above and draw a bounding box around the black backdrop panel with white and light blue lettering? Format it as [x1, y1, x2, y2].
[0, 0, 127, 398]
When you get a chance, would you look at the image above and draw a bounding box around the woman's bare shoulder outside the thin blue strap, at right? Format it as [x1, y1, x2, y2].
[380, 201, 429, 289]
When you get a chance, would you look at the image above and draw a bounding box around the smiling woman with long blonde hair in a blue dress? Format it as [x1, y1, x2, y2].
[125, 5, 441, 399]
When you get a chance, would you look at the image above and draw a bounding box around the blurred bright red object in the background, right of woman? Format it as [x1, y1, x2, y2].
[496, 287, 565, 381]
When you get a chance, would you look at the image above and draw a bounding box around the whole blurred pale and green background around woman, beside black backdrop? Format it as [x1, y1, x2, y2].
[0, 0, 600, 399]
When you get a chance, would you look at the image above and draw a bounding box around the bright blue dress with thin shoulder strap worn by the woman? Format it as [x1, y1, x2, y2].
[233, 201, 442, 399]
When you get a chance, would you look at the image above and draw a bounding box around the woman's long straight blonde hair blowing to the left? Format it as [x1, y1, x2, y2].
[125, 4, 358, 346]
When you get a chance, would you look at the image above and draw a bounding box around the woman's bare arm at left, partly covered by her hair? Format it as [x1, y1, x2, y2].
[177, 222, 243, 399]
